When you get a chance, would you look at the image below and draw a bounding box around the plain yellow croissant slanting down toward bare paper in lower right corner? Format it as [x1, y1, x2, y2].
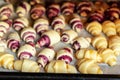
[98, 48, 117, 66]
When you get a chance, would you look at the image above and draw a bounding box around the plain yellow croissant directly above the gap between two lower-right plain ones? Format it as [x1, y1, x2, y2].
[92, 36, 108, 49]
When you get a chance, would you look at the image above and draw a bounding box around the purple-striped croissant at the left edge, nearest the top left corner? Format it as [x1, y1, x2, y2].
[0, 4, 13, 20]
